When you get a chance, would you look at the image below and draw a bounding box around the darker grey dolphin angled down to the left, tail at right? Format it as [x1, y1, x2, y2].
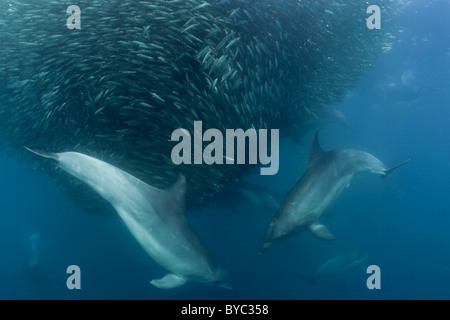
[259, 131, 411, 253]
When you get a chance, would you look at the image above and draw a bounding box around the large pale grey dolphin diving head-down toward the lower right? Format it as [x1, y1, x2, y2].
[26, 148, 231, 289]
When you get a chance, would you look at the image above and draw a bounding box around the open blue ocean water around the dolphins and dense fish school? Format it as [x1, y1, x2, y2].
[0, 0, 450, 299]
